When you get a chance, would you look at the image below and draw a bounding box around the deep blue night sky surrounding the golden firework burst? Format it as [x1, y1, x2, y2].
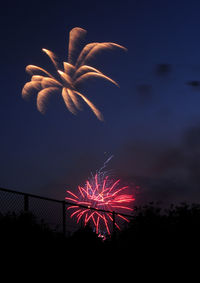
[0, 0, 200, 203]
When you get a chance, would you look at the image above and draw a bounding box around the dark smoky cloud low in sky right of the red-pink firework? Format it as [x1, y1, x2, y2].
[111, 126, 200, 204]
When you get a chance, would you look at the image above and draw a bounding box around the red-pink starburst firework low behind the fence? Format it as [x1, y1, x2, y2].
[65, 171, 135, 235]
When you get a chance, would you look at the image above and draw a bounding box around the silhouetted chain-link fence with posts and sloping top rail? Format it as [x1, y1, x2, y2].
[0, 188, 133, 236]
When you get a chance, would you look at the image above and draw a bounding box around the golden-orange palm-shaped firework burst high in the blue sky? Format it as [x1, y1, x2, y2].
[22, 27, 127, 121]
